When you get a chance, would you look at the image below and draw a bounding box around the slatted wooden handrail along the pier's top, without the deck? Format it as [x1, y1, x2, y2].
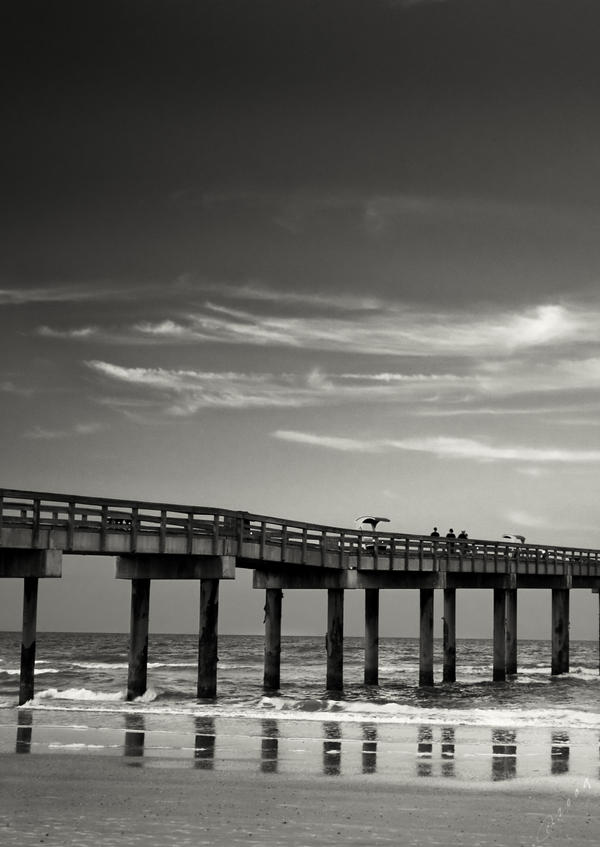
[0, 488, 600, 571]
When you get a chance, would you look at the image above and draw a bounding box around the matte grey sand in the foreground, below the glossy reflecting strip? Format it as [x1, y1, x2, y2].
[0, 753, 600, 847]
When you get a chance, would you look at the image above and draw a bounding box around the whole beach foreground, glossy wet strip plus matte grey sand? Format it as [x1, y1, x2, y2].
[0, 712, 600, 847]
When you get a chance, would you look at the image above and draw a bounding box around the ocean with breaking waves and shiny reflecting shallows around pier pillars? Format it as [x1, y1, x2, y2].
[0, 632, 600, 785]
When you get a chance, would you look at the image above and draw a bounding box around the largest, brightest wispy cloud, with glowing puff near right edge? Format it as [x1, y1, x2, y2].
[132, 302, 600, 358]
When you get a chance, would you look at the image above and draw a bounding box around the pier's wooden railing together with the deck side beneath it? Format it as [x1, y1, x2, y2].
[0, 488, 600, 576]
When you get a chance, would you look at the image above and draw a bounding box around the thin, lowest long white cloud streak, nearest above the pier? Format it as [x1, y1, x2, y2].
[272, 430, 600, 464]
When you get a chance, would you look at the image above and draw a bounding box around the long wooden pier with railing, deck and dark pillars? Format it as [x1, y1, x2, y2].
[0, 489, 600, 704]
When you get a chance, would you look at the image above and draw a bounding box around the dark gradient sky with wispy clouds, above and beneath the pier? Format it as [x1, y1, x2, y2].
[0, 0, 600, 638]
